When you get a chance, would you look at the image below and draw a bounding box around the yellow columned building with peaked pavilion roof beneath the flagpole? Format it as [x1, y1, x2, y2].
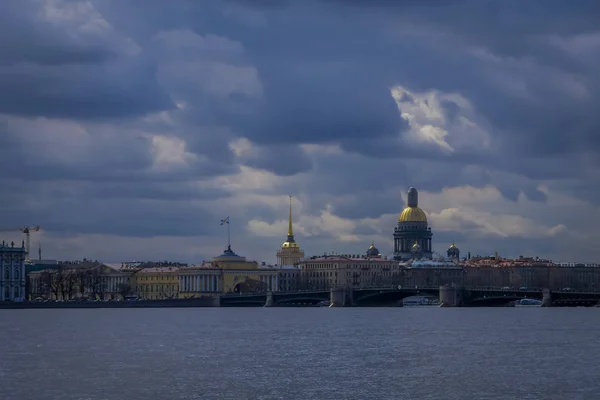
[179, 246, 279, 298]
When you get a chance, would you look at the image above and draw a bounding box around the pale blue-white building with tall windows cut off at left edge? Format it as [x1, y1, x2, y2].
[0, 242, 26, 301]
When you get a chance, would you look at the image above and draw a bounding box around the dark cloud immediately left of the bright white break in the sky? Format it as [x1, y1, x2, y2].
[232, 63, 403, 147]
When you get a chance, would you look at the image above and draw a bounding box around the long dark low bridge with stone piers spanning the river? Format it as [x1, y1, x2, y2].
[219, 286, 600, 307]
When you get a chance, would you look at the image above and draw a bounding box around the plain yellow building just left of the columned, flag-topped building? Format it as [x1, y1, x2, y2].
[131, 267, 180, 300]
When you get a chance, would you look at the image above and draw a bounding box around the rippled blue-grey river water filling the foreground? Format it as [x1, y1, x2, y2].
[0, 307, 600, 400]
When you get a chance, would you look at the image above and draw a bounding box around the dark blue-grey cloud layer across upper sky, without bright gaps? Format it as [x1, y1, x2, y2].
[0, 0, 600, 260]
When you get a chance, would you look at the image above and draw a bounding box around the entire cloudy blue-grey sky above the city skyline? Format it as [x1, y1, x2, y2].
[0, 0, 600, 263]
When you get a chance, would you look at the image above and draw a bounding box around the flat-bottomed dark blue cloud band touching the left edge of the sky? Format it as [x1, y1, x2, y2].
[0, 62, 173, 118]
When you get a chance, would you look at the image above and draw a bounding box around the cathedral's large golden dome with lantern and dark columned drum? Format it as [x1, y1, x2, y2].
[394, 187, 433, 261]
